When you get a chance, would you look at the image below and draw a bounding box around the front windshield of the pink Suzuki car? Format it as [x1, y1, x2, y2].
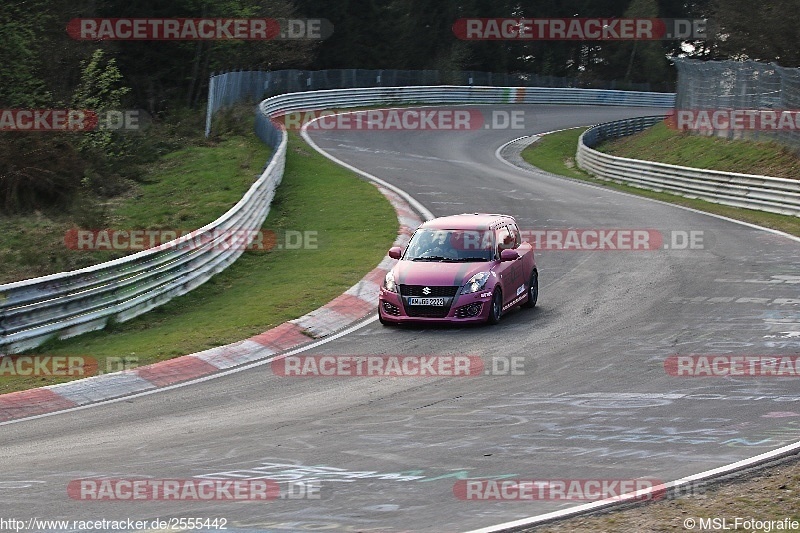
[403, 228, 494, 263]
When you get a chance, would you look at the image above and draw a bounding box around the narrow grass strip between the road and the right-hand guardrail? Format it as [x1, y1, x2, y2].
[522, 128, 800, 236]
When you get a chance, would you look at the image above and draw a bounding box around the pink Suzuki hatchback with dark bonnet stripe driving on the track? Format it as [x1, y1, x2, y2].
[378, 213, 539, 325]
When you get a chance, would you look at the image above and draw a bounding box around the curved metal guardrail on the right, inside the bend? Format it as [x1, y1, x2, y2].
[576, 115, 800, 216]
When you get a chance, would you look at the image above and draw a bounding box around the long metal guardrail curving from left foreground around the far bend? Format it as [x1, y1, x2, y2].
[0, 86, 675, 353]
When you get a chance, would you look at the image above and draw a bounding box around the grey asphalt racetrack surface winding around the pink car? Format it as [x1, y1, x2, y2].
[0, 106, 800, 533]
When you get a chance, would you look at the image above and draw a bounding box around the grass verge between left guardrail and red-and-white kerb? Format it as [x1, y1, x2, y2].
[0, 134, 397, 393]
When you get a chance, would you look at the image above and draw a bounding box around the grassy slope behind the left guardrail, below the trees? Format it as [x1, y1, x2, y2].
[0, 135, 270, 284]
